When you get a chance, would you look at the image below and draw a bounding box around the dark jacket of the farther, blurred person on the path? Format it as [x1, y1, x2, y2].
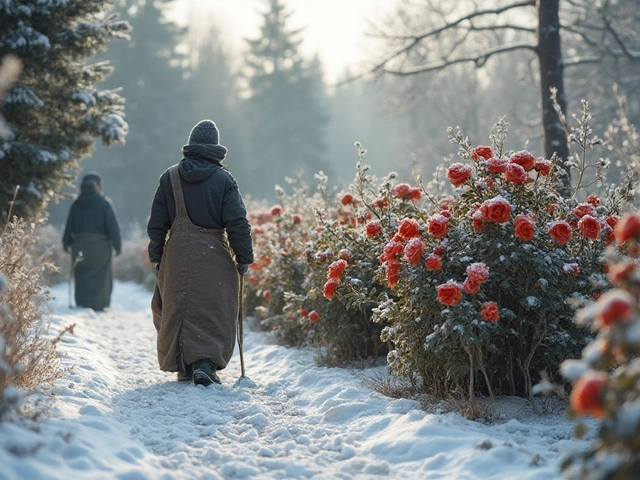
[62, 183, 122, 255]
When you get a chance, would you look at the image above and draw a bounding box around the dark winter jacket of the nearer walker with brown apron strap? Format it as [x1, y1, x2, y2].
[147, 144, 253, 264]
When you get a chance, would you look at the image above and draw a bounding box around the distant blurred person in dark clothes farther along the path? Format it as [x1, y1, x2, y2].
[62, 173, 122, 311]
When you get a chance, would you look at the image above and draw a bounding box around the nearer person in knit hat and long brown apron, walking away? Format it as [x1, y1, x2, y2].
[147, 120, 253, 386]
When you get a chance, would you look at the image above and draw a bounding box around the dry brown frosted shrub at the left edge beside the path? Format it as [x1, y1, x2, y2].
[0, 218, 73, 418]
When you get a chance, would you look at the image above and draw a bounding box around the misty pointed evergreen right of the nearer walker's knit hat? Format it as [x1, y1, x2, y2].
[241, 0, 329, 197]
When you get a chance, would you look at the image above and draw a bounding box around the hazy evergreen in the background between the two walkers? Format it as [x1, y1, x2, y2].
[78, 0, 191, 223]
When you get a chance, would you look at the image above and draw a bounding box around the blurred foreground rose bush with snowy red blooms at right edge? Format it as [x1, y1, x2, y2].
[562, 212, 640, 479]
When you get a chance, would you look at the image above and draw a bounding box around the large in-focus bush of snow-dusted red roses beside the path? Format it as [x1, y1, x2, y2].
[368, 119, 618, 406]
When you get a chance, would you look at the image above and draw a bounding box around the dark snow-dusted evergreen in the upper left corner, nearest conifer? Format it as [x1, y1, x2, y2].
[0, 0, 129, 225]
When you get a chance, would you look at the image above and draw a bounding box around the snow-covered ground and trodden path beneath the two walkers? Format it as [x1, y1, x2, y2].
[0, 283, 596, 480]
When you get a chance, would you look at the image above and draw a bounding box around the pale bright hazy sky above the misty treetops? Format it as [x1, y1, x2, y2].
[168, 0, 396, 83]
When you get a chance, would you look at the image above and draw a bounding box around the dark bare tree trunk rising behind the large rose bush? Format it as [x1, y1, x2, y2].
[537, 0, 570, 186]
